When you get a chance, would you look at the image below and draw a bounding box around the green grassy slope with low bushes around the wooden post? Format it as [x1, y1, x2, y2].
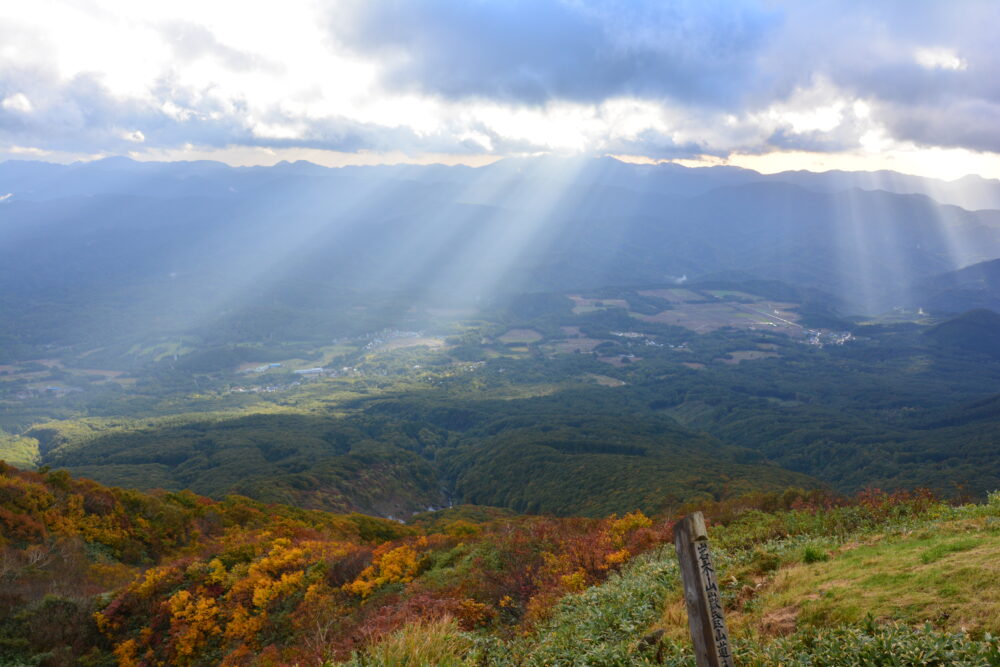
[352, 494, 1000, 666]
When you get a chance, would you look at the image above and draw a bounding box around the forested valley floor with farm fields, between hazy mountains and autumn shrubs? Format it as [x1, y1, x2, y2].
[0, 282, 1000, 518]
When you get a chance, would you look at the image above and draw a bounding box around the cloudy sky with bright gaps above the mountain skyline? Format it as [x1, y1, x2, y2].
[0, 0, 1000, 179]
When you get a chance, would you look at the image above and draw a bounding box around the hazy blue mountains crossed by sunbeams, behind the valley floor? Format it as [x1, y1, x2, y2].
[0, 158, 1000, 358]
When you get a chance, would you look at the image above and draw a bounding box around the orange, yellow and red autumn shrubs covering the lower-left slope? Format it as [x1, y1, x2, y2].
[0, 464, 670, 665]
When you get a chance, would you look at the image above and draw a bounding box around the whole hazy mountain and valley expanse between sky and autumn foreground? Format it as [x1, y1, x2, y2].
[0, 159, 1000, 517]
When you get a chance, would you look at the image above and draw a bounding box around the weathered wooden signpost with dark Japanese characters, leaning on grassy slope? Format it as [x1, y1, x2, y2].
[674, 512, 734, 667]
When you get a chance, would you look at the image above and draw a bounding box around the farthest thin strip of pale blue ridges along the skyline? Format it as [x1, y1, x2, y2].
[0, 157, 1000, 210]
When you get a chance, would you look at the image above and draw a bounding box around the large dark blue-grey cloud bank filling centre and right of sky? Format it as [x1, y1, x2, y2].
[332, 0, 1000, 150]
